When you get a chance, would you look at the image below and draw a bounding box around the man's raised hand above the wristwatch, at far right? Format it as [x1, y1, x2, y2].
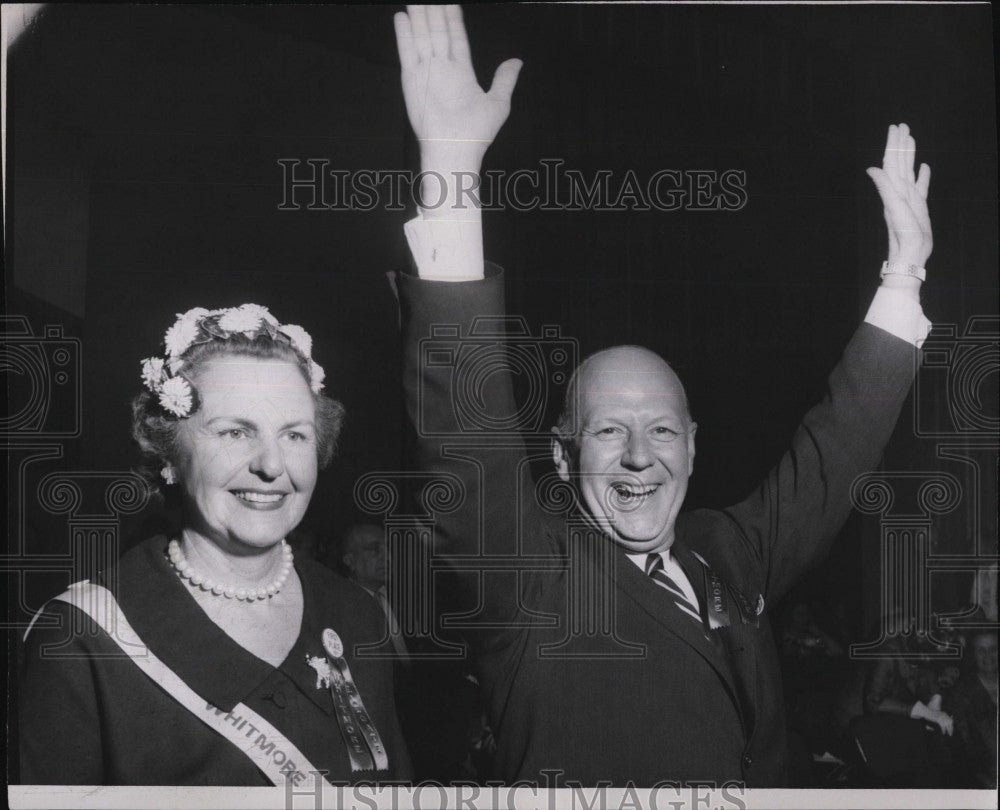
[868, 124, 934, 270]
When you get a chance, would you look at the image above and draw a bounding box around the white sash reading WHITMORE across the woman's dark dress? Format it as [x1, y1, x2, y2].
[36, 580, 327, 785]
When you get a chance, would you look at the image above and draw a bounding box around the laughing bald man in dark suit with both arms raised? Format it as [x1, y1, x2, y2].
[396, 6, 931, 787]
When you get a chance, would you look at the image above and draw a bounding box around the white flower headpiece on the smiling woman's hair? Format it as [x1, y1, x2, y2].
[142, 304, 326, 418]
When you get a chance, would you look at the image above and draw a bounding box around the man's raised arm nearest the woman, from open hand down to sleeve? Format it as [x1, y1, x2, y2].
[395, 6, 540, 640]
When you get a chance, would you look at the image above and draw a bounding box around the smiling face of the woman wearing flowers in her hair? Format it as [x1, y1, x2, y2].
[175, 355, 318, 554]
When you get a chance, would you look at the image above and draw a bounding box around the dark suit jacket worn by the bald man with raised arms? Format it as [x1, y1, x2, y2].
[399, 267, 916, 787]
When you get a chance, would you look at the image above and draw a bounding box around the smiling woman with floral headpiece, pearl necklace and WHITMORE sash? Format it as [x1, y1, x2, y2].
[20, 304, 410, 788]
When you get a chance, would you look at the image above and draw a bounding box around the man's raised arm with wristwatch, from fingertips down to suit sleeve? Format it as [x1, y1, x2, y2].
[726, 124, 933, 599]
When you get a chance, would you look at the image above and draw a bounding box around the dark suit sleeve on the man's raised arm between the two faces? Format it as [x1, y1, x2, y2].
[397, 265, 554, 638]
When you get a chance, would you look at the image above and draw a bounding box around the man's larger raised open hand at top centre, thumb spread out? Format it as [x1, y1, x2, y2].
[394, 5, 521, 171]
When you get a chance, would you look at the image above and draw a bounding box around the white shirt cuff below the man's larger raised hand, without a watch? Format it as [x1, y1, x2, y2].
[403, 210, 485, 281]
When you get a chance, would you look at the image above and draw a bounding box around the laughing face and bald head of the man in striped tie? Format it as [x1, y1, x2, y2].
[553, 346, 697, 553]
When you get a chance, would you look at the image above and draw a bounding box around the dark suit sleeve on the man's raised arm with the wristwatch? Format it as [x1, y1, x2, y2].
[725, 323, 918, 600]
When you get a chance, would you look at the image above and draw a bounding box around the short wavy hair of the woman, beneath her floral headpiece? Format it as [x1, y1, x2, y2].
[132, 333, 344, 500]
